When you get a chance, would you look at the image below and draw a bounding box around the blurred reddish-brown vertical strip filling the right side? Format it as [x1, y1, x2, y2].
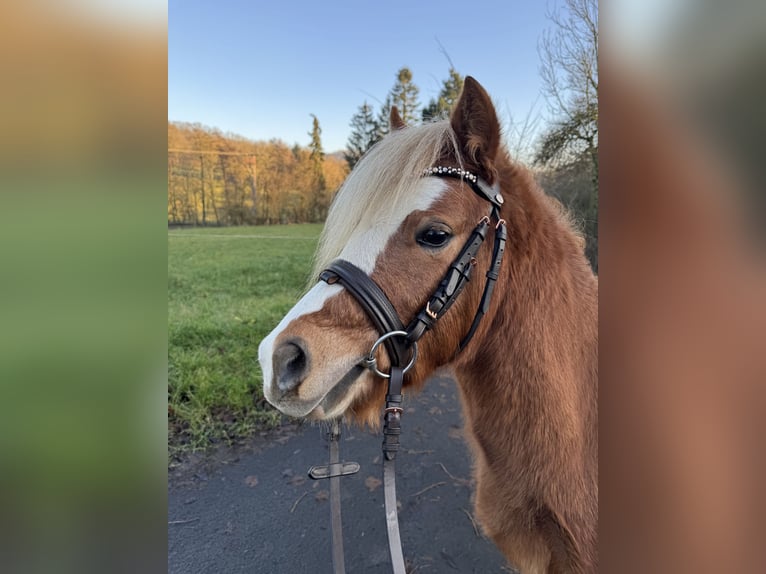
[599, 2, 766, 573]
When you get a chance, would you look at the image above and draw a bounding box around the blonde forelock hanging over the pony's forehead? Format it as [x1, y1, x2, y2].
[310, 120, 462, 284]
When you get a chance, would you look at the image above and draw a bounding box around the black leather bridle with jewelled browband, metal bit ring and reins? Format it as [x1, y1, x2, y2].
[309, 166, 507, 574]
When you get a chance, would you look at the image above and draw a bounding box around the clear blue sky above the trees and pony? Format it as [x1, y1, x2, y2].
[168, 0, 553, 152]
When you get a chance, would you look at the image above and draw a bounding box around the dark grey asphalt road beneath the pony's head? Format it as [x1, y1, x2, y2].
[168, 377, 513, 574]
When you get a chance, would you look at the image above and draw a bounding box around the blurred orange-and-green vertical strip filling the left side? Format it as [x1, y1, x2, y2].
[0, 1, 167, 573]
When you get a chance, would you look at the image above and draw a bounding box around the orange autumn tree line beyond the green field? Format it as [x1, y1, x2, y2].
[168, 117, 348, 225]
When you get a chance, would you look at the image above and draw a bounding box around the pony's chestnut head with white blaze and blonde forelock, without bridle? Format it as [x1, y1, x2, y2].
[259, 77, 508, 424]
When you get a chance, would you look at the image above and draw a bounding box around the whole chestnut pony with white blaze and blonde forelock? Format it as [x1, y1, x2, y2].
[258, 76, 598, 574]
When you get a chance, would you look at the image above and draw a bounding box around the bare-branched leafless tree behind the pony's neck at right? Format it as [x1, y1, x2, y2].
[535, 0, 598, 270]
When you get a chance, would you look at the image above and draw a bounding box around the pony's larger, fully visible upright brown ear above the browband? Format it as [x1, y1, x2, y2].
[450, 76, 500, 183]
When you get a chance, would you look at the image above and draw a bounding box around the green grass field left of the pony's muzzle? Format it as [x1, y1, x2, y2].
[168, 224, 321, 453]
